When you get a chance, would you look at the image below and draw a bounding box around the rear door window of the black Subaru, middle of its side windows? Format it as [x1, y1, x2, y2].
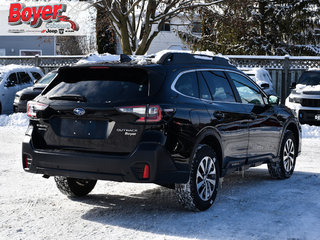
[201, 71, 236, 102]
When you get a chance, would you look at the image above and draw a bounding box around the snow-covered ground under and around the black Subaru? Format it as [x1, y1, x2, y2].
[0, 114, 320, 240]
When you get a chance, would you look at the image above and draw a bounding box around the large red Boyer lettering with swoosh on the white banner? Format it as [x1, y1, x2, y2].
[8, 3, 79, 31]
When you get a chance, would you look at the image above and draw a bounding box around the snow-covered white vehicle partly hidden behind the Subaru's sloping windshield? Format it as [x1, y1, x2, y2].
[240, 68, 277, 95]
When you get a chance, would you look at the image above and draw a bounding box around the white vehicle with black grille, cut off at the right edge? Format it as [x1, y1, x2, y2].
[286, 70, 320, 126]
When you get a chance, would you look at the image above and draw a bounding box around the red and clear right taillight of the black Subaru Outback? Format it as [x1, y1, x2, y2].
[118, 105, 162, 122]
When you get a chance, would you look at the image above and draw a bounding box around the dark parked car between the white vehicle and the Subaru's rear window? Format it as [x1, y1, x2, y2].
[13, 70, 58, 112]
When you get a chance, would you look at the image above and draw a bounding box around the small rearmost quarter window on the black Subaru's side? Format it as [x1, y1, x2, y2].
[175, 72, 199, 98]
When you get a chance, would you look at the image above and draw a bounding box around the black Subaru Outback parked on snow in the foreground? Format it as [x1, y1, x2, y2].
[22, 52, 301, 210]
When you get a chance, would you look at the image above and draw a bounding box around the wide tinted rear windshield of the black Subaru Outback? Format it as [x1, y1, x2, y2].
[45, 67, 148, 104]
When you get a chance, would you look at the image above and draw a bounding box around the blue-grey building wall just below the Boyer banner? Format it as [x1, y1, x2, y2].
[0, 36, 56, 56]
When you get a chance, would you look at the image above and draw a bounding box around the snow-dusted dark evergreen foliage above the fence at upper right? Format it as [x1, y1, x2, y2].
[188, 0, 320, 55]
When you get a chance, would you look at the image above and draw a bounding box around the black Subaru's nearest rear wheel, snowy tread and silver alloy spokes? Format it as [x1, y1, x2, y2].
[175, 145, 219, 211]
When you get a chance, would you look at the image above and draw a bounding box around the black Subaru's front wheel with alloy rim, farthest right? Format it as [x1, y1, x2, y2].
[268, 130, 297, 179]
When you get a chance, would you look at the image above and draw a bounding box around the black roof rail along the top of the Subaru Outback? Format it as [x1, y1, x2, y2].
[157, 52, 235, 68]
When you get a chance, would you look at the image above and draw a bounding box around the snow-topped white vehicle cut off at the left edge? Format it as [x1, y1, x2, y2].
[0, 65, 43, 114]
